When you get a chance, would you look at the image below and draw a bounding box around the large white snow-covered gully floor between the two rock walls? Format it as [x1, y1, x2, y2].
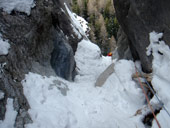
[22, 40, 144, 128]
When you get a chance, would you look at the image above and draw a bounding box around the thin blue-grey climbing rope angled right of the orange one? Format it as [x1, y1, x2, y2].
[136, 68, 170, 117]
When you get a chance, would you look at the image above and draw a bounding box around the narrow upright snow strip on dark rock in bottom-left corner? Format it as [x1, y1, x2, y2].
[0, 98, 17, 128]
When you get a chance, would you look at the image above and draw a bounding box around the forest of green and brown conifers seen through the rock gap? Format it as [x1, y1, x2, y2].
[73, 0, 119, 54]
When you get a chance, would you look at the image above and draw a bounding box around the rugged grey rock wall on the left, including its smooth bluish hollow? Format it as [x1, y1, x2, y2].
[0, 0, 80, 128]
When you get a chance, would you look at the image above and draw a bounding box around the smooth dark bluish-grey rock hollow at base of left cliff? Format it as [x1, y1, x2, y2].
[51, 33, 75, 80]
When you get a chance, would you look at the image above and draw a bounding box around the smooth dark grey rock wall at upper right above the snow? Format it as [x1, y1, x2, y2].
[114, 0, 170, 72]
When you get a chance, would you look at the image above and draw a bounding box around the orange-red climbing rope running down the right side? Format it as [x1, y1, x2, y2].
[135, 66, 161, 128]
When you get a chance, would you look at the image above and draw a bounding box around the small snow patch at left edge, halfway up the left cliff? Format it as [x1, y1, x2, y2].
[0, 34, 10, 55]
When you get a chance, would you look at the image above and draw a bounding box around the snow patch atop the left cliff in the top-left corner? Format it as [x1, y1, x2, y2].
[0, 0, 35, 15]
